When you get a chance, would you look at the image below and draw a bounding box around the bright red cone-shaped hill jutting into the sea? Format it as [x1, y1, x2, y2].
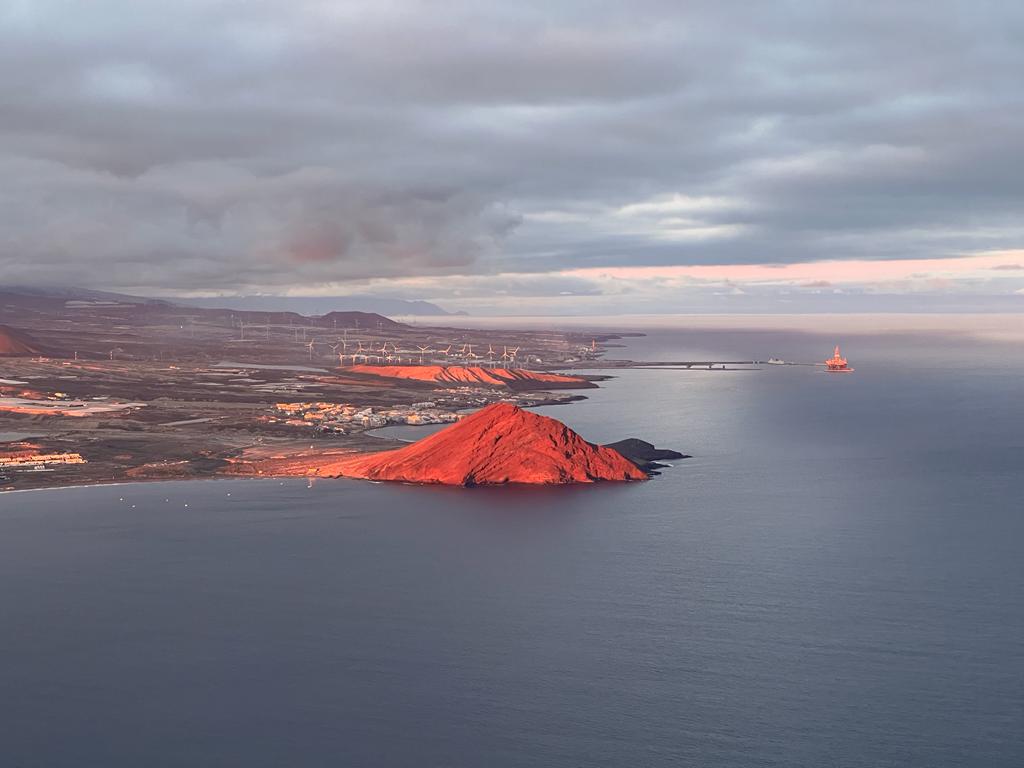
[318, 402, 647, 485]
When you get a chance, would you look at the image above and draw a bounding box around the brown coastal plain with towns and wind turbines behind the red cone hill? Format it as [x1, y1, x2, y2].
[0, 287, 643, 490]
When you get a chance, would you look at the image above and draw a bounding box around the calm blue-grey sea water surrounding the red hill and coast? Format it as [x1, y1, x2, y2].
[0, 331, 1024, 768]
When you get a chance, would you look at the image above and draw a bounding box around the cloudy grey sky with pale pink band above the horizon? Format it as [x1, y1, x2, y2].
[0, 0, 1024, 313]
